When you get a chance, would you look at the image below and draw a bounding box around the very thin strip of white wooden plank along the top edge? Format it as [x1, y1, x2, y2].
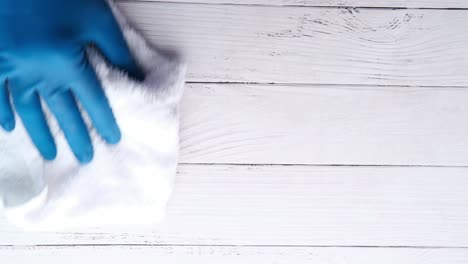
[119, 0, 468, 8]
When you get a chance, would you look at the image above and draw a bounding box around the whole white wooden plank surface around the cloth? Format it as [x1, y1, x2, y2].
[0, 0, 468, 264]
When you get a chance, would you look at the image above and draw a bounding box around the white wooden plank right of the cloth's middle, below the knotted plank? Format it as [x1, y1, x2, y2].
[181, 84, 468, 166]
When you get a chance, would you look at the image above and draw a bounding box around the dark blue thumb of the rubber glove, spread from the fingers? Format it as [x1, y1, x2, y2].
[91, 10, 144, 81]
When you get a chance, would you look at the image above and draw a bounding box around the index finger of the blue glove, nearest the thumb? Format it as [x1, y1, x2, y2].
[72, 62, 121, 144]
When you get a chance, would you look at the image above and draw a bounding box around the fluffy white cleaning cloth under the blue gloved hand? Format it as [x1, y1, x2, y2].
[0, 1, 185, 230]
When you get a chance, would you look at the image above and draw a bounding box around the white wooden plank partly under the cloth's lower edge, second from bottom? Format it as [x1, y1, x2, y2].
[0, 165, 468, 247]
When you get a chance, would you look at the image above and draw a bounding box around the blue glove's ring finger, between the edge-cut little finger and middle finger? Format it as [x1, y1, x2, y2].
[11, 89, 57, 160]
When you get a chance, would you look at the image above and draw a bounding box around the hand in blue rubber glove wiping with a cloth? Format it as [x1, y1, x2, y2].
[0, 0, 143, 163]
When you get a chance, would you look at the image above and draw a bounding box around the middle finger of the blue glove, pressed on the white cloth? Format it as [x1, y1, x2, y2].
[44, 91, 94, 163]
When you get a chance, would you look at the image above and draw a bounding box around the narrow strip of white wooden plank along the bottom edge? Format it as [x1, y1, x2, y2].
[0, 246, 468, 264]
